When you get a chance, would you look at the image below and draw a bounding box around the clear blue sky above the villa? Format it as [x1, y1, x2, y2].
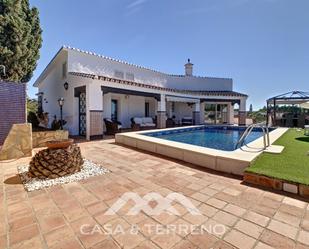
[28, 0, 309, 109]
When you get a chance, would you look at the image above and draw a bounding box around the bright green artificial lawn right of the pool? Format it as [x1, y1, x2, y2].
[246, 129, 309, 185]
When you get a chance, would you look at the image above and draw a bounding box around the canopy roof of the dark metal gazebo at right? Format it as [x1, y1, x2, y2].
[267, 91, 309, 105]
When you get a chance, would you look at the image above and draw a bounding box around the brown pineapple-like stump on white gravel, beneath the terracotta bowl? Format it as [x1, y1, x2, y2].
[29, 144, 84, 179]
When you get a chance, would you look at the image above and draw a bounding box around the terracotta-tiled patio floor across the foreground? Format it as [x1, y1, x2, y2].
[0, 140, 309, 249]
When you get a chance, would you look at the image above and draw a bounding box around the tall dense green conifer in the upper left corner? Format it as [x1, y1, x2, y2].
[0, 0, 42, 82]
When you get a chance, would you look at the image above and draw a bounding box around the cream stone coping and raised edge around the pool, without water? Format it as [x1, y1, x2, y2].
[115, 125, 288, 175]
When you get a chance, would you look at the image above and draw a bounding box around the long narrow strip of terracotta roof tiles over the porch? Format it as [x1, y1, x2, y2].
[69, 72, 248, 97]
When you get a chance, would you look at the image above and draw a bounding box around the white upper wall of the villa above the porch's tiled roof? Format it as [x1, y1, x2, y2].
[68, 49, 233, 91]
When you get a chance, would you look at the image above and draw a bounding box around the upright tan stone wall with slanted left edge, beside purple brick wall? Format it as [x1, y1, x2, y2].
[0, 124, 32, 160]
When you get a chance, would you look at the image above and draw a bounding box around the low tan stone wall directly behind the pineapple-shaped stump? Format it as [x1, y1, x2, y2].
[32, 130, 69, 148]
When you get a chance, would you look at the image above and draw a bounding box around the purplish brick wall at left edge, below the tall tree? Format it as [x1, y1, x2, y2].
[0, 81, 26, 145]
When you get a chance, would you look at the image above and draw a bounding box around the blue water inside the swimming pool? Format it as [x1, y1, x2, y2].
[143, 126, 272, 151]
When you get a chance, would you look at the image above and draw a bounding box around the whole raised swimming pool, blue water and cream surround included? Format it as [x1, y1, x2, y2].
[115, 125, 288, 175]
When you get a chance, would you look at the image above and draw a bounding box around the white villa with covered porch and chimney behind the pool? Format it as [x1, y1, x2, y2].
[34, 47, 248, 139]
